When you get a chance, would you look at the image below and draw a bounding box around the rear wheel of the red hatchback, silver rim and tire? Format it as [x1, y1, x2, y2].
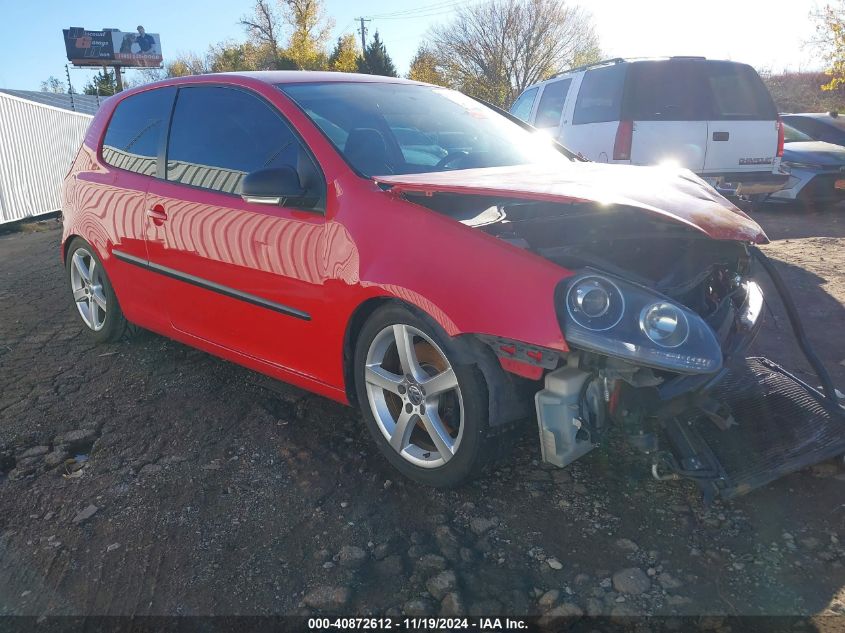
[65, 237, 134, 343]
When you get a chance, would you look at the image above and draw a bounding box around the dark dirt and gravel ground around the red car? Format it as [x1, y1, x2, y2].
[0, 208, 845, 615]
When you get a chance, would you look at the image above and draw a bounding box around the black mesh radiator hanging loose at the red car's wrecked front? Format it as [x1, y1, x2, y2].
[653, 358, 845, 499]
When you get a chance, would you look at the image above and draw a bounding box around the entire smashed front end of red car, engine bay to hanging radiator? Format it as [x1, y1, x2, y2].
[388, 177, 845, 498]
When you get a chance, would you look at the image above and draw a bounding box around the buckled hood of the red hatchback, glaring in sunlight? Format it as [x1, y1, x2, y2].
[373, 162, 769, 244]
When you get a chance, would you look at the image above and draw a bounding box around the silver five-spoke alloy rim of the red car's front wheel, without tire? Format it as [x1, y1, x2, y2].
[364, 324, 464, 468]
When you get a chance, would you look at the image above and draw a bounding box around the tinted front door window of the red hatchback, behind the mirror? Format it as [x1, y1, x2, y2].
[167, 87, 308, 194]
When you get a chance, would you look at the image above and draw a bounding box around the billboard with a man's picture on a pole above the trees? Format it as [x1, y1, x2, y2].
[62, 26, 162, 68]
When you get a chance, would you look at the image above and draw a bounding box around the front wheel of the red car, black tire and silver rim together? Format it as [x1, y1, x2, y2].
[354, 305, 497, 488]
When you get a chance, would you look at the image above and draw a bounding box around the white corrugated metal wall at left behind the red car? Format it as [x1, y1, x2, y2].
[0, 91, 93, 224]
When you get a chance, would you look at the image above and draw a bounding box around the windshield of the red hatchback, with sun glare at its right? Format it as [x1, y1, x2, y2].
[279, 82, 569, 176]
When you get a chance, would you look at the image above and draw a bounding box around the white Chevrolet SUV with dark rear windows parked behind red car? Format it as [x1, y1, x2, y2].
[510, 57, 787, 195]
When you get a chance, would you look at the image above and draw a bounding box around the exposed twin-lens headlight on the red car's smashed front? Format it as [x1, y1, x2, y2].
[558, 272, 722, 374]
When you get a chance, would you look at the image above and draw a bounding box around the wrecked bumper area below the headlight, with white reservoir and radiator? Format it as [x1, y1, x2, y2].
[535, 249, 845, 499]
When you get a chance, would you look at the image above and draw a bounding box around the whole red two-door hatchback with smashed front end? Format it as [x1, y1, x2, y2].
[62, 72, 845, 496]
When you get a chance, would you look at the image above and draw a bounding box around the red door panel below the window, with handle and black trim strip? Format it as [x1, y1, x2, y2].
[146, 181, 326, 379]
